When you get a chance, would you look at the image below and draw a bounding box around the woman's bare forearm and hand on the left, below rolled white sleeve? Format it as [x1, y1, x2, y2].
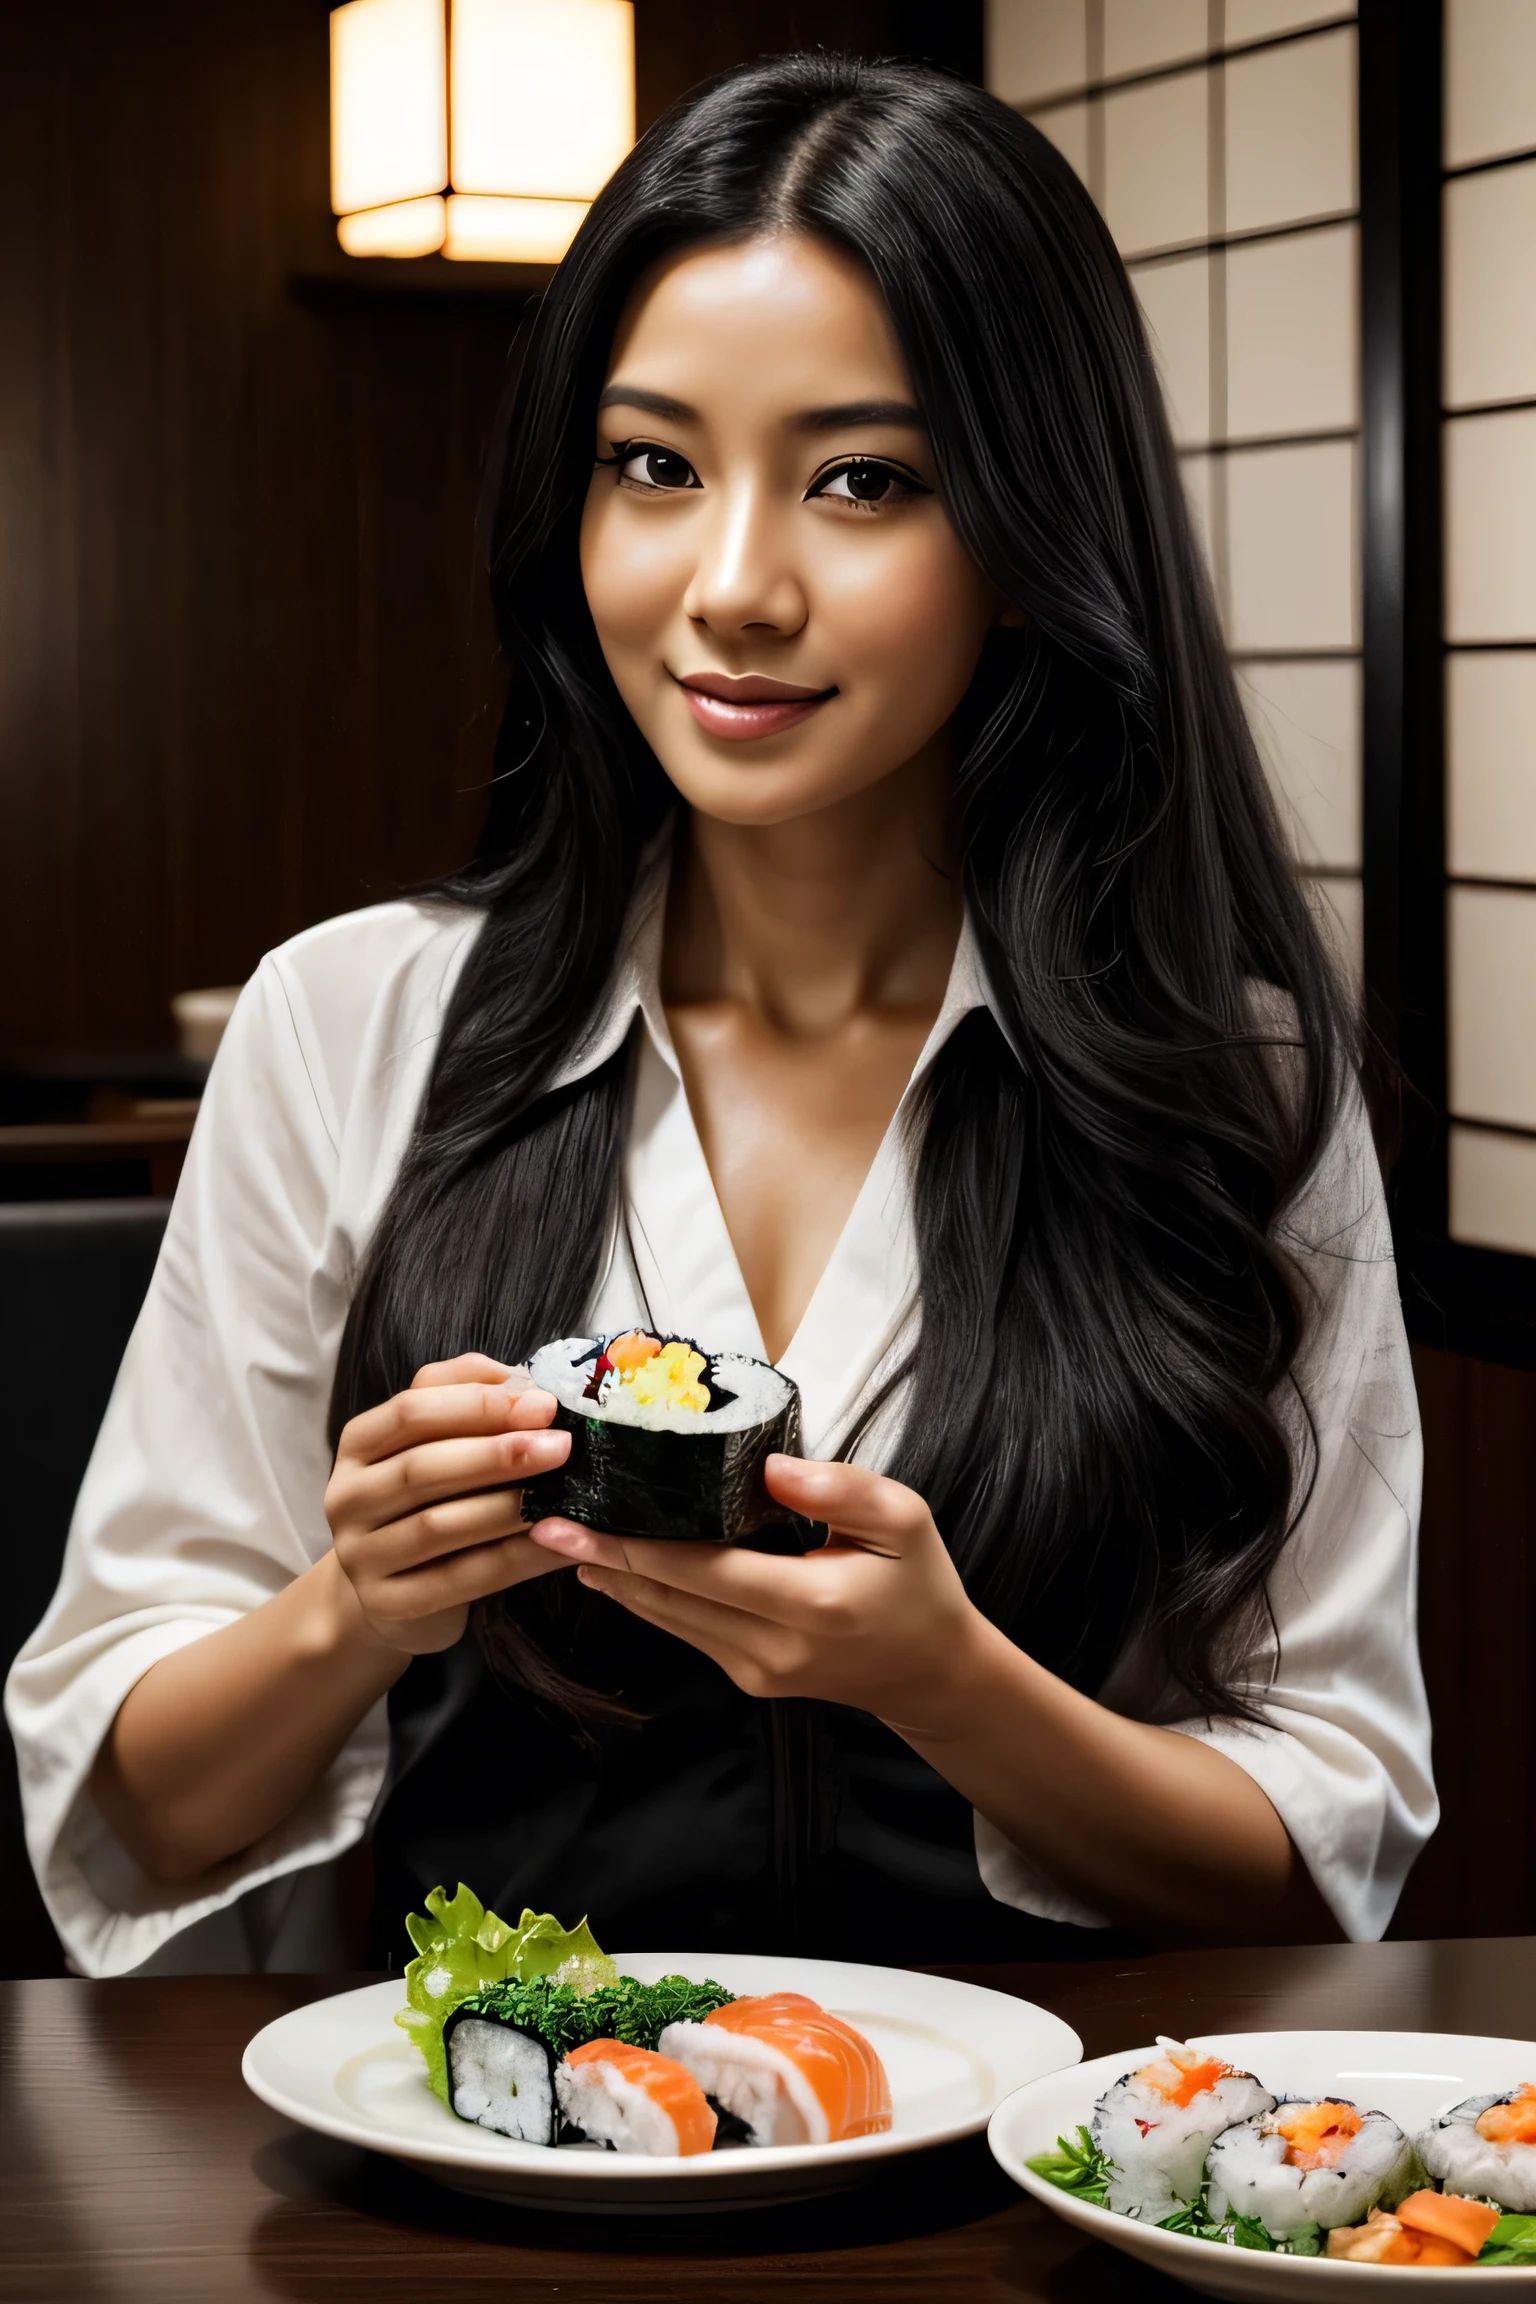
[90, 1355, 571, 1880]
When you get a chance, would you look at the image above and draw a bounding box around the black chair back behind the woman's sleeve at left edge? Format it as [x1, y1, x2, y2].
[0, 1200, 170, 1977]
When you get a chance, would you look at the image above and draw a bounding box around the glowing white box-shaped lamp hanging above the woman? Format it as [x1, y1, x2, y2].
[332, 0, 636, 265]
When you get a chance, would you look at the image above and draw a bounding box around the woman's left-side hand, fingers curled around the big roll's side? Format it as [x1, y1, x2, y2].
[325, 1352, 571, 1657]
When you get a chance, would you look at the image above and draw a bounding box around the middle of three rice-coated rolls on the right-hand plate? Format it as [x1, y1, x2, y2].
[1207, 2097, 1414, 2239]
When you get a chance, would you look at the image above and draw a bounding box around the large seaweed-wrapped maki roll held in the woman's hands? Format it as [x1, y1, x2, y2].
[523, 1329, 822, 1553]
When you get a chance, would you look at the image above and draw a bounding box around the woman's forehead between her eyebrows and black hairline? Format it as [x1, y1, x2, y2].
[608, 233, 910, 415]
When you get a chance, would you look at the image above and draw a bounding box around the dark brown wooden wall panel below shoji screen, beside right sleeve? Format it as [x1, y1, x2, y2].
[1391, 1346, 1536, 1938]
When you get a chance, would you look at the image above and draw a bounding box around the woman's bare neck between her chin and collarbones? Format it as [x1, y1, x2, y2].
[661, 742, 963, 1037]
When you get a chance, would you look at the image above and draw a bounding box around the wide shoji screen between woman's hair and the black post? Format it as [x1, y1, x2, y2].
[988, 0, 1354, 975]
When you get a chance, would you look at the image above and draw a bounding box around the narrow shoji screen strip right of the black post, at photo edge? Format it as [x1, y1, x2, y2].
[1444, 0, 1536, 1256]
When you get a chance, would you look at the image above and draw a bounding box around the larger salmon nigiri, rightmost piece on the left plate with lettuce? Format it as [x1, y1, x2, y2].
[659, 1993, 891, 2145]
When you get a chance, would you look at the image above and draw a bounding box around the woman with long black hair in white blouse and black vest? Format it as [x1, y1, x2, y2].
[12, 58, 1435, 1972]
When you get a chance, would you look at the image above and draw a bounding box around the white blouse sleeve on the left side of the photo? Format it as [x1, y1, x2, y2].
[7, 958, 387, 1977]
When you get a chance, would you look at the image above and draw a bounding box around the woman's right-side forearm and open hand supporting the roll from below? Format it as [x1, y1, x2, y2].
[534, 1456, 1338, 1942]
